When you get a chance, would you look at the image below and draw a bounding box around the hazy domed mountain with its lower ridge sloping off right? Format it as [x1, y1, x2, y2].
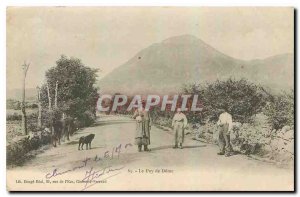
[99, 35, 294, 94]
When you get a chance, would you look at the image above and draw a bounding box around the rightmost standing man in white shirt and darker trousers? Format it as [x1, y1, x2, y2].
[217, 109, 232, 157]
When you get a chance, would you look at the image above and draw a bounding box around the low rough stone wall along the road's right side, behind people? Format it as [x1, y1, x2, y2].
[155, 115, 294, 165]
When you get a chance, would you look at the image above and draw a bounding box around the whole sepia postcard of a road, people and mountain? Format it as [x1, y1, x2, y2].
[4, 6, 296, 192]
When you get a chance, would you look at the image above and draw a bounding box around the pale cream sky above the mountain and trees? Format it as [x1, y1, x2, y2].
[6, 7, 294, 89]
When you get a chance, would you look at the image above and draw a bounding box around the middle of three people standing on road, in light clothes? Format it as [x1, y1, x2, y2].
[172, 108, 187, 149]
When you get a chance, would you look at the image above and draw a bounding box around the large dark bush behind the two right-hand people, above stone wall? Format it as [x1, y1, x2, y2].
[183, 79, 269, 123]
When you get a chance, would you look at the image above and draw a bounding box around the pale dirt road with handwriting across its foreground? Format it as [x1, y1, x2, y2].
[7, 116, 294, 190]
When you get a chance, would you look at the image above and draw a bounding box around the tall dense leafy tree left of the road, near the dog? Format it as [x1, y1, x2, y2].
[41, 55, 98, 125]
